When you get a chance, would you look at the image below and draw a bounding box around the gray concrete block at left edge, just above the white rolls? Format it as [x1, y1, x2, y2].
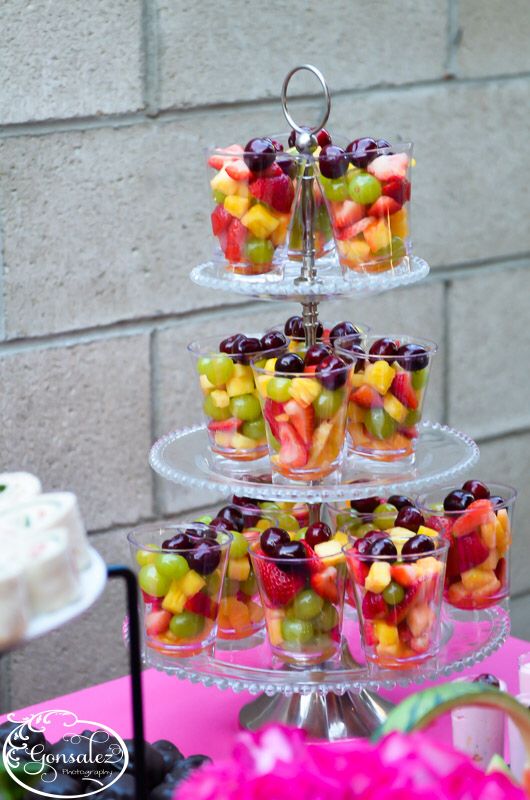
[0, 336, 151, 529]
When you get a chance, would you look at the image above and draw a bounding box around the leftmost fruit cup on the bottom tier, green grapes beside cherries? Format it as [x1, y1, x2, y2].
[127, 522, 232, 657]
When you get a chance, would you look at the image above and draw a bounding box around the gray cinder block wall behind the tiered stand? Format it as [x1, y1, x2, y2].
[0, 0, 530, 709]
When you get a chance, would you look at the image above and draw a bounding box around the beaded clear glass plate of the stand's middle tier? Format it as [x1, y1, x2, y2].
[149, 422, 479, 503]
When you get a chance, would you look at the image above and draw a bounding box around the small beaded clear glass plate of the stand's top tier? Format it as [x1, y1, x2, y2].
[191, 256, 429, 302]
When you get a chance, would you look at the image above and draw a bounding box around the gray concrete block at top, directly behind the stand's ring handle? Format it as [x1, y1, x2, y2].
[158, 0, 446, 108]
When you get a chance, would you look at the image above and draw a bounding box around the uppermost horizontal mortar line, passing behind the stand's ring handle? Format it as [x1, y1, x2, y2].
[0, 70, 530, 139]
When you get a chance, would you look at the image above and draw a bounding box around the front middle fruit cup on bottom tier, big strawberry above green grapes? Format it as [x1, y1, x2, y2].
[250, 542, 346, 666]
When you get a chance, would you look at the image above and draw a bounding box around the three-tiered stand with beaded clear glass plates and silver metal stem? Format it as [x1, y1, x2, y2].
[144, 65, 510, 740]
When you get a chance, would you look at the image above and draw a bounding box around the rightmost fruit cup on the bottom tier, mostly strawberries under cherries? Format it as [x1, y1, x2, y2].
[418, 479, 517, 609]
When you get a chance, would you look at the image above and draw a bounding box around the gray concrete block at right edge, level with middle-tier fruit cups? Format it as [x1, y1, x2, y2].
[448, 269, 530, 436]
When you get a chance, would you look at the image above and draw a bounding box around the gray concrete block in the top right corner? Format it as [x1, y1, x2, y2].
[457, 0, 530, 77]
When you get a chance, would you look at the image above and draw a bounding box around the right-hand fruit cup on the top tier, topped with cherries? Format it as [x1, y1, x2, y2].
[318, 137, 412, 273]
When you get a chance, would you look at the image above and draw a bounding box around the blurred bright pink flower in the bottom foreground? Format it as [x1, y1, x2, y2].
[174, 726, 525, 800]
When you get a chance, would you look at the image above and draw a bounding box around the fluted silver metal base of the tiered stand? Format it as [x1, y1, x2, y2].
[239, 689, 393, 742]
